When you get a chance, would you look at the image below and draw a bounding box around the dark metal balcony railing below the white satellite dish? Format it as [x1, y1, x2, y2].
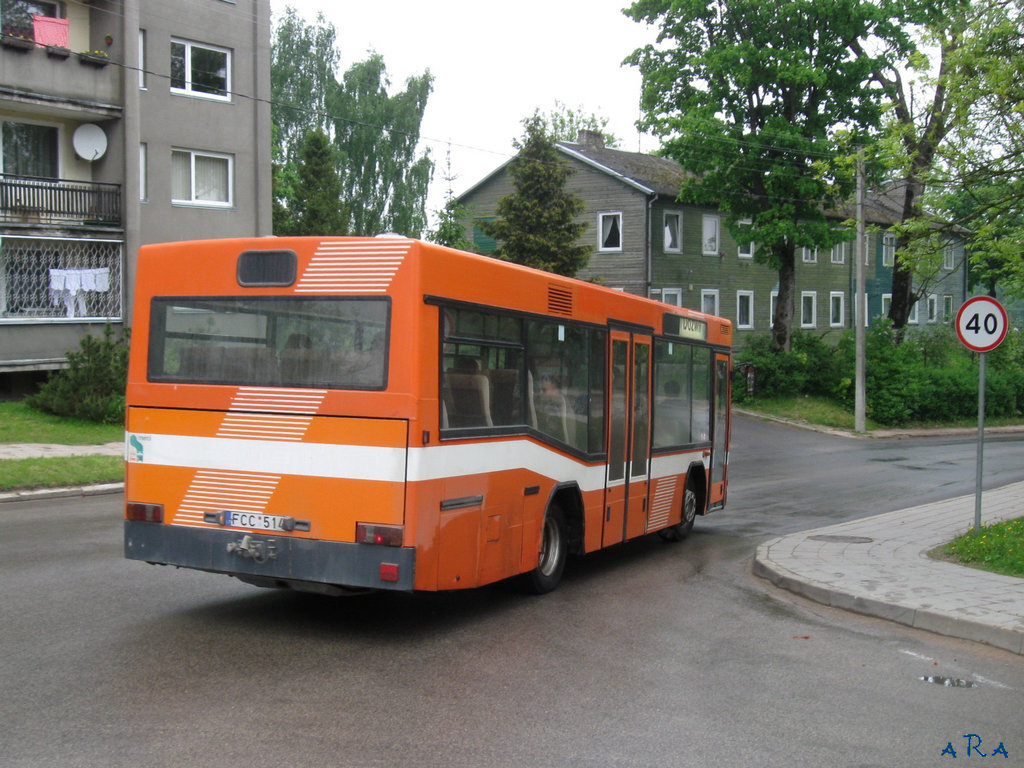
[0, 174, 121, 226]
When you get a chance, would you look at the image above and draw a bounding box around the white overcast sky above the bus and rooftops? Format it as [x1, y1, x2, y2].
[271, 0, 654, 217]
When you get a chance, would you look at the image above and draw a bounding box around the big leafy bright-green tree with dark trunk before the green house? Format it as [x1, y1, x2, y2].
[626, 0, 902, 349]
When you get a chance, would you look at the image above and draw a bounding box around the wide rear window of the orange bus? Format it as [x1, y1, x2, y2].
[147, 296, 390, 389]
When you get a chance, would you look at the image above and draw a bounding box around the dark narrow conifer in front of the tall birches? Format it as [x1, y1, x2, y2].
[288, 129, 348, 236]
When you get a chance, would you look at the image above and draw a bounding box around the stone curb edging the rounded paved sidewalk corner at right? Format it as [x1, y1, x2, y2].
[752, 537, 1024, 655]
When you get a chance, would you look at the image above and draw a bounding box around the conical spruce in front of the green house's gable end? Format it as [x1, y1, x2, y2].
[482, 113, 591, 278]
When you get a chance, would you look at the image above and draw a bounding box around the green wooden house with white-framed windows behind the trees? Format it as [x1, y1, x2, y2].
[459, 131, 967, 345]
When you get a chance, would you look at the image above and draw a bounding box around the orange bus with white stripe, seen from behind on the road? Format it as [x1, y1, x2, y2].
[125, 237, 732, 593]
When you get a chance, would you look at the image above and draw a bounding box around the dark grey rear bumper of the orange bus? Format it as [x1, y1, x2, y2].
[125, 520, 416, 592]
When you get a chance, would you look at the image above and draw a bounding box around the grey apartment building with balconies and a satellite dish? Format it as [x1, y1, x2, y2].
[0, 0, 271, 379]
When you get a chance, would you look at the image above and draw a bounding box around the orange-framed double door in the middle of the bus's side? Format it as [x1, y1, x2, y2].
[601, 331, 651, 547]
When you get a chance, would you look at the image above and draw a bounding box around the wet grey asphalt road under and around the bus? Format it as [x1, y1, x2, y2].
[0, 418, 1024, 768]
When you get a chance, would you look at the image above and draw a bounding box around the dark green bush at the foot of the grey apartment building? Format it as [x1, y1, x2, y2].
[26, 325, 128, 424]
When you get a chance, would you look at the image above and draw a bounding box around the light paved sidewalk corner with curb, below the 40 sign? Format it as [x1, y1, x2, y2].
[754, 482, 1024, 653]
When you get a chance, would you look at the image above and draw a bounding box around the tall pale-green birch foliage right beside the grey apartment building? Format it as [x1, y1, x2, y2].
[270, 7, 433, 237]
